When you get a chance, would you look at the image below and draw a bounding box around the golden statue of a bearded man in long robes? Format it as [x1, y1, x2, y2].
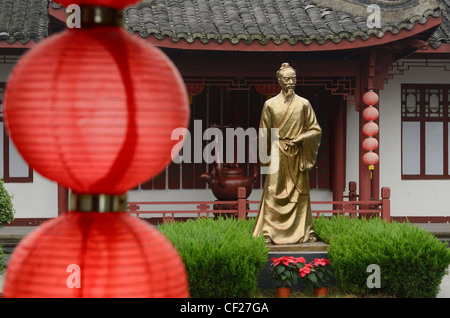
[253, 63, 322, 244]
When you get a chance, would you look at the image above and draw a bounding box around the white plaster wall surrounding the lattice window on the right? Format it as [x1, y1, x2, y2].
[376, 60, 450, 216]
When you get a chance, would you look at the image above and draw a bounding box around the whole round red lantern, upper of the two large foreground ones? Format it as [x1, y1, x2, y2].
[4, 27, 189, 194]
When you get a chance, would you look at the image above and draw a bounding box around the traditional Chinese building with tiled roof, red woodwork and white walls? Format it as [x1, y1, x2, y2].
[0, 0, 450, 224]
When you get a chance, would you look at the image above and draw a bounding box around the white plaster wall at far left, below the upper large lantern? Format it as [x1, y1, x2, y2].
[0, 64, 58, 219]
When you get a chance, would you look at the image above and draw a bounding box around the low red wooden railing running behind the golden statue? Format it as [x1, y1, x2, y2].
[128, 182, 391, 223]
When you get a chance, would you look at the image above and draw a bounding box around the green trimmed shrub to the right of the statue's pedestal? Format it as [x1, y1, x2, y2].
[314, 216, 450, 298]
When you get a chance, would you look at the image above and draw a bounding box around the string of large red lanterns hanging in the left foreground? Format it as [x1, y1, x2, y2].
[3, 0, 189, 297]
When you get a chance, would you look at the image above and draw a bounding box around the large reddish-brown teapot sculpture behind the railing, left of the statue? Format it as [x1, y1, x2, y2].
[200, 162, 259, 201]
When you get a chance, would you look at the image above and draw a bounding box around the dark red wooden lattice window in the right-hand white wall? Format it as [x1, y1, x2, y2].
[401, 84, 450, 179]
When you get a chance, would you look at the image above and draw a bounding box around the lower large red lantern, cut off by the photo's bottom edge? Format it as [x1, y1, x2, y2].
[3, 212, 189, 298]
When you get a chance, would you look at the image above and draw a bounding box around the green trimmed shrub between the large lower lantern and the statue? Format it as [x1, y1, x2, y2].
[159, 218, 268, 298]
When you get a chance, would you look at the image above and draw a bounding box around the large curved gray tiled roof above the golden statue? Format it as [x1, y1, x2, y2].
[125, 0, 442, 45]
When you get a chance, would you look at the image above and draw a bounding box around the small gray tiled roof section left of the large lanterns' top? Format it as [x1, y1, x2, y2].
[0, 0, 49, 44]
